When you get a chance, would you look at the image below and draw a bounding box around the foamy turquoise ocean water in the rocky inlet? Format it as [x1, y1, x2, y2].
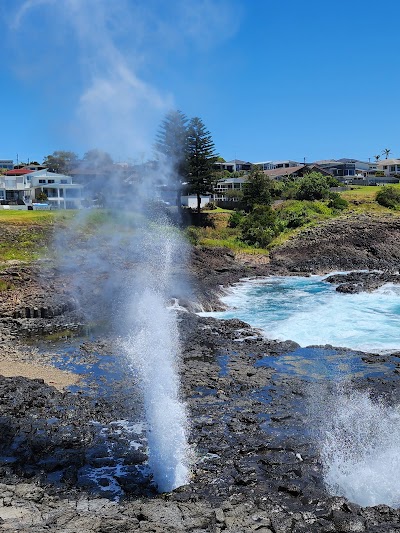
[201, 276, 400, 353]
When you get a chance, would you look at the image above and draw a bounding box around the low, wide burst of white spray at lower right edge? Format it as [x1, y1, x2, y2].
[310, 383, 400, 507]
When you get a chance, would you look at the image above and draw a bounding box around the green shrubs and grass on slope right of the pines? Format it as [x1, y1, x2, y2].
[187, 180, 400, 254]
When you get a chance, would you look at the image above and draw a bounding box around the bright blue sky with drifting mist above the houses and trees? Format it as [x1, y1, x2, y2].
[0, 0, 400, 162]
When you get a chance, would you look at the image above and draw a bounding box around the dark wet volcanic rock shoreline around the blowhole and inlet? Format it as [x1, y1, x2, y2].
[0, 217, 400, 533]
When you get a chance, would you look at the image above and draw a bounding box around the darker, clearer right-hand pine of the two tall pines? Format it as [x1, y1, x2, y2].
[187, 117, 217, 213]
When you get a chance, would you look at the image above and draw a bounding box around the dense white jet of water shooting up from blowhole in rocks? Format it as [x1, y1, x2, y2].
[125, 221, 190, 492]
